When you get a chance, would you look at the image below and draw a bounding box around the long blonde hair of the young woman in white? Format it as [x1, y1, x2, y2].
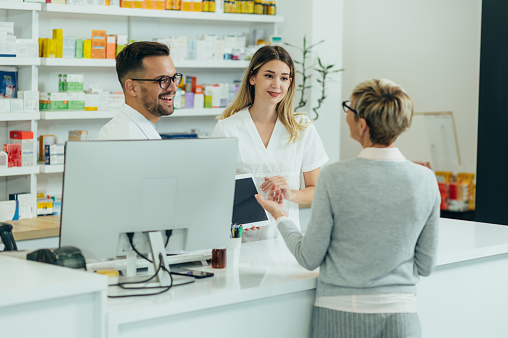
[219, 46, 309, 142]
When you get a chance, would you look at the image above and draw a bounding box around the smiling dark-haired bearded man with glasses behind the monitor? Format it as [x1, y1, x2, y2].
[97, 41, 182, 140]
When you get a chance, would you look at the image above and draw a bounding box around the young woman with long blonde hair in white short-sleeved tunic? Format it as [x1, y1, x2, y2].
[212, 46, 328, 242]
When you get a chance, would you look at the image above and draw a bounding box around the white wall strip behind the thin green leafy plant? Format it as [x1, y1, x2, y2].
[279, 0, 343, 163]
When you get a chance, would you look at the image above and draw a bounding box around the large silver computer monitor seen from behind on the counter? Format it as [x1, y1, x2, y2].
[60, 138, 237, 286]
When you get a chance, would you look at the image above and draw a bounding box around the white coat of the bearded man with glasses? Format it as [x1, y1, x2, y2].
[96, 103, 161, 140]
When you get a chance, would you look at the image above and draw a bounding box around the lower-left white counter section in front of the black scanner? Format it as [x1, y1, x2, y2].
[0, 255, 107, 338]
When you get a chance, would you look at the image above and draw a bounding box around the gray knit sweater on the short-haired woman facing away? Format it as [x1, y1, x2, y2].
[278, 158, 440, 296]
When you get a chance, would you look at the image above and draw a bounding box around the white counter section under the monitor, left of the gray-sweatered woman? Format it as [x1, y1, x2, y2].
[107, 241, 318, 338]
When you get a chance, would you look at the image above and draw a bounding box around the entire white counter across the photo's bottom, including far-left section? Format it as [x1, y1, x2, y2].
[0, 219, 508, 338]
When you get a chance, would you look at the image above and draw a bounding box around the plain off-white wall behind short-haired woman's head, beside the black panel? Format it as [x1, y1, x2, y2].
[340, 0, 481, 172]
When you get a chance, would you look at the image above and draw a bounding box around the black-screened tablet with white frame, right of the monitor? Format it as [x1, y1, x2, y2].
[232, 174, 272, 229]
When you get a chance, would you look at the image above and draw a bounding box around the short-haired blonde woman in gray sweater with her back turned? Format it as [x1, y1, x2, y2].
[256, 80, 440, 338]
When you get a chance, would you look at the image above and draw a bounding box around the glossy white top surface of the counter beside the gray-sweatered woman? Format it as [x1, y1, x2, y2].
[107, 218, 508, 324]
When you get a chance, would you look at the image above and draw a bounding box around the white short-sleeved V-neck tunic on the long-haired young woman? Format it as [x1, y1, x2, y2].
[212, 108, 328, 242]
